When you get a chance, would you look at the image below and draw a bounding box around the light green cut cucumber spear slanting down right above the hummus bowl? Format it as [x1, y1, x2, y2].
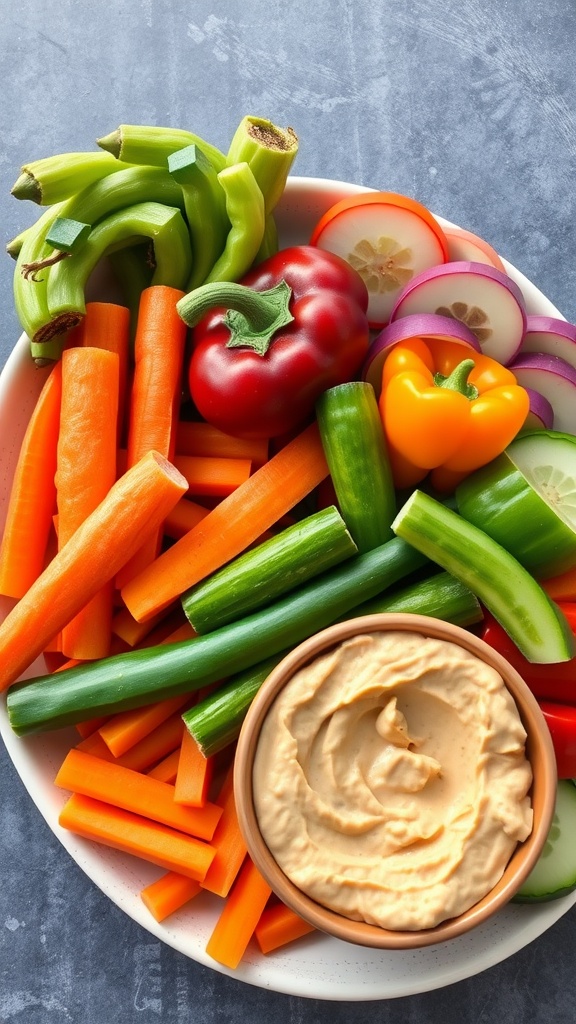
[393, 490, 576, 665]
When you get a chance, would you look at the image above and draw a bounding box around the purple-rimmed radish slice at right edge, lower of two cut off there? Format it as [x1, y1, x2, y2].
[509, 352, 576, 434]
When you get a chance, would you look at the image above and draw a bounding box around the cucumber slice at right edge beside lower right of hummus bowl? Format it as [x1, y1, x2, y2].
[513, 779, 576, 903]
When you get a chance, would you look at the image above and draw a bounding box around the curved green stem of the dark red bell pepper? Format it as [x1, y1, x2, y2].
[176, 281, 294, 355]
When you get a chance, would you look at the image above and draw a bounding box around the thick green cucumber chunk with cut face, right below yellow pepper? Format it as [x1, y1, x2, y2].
[456, 430, 576, 580]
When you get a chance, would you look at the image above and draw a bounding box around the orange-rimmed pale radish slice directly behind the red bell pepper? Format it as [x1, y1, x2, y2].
[311, 191, 448, 328]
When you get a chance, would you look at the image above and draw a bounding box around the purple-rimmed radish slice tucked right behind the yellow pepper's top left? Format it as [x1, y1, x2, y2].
[362, 313, 480, 397]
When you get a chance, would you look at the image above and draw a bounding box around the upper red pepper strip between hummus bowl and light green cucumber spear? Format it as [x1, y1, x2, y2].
[481, 604, 576, 707]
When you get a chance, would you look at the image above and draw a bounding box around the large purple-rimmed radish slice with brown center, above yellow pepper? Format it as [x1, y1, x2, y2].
[390, 261, 527, 366]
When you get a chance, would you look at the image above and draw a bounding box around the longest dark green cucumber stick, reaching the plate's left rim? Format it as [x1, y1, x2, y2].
[7, 538, 427, 735]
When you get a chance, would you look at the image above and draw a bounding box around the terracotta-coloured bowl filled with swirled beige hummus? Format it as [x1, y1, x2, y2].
[235, 613, 557, 948]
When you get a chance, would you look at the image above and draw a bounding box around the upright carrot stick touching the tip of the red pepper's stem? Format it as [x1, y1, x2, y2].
[117, 285, 187, 588]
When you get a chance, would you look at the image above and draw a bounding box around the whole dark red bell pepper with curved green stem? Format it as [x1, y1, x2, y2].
[177, 246, 370, 437]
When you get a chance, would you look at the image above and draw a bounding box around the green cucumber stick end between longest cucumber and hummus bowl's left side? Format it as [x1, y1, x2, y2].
[182, 650, 288, 758]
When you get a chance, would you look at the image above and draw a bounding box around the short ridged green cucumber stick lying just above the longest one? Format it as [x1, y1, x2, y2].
[181, 505, 358, 634]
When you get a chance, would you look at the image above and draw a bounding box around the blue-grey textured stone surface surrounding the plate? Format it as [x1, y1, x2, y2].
[0, 0, 576, 1024]
